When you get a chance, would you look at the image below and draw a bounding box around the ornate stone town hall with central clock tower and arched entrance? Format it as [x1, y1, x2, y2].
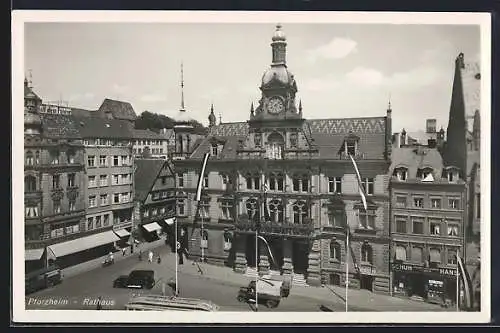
[174, 26, 392, 292]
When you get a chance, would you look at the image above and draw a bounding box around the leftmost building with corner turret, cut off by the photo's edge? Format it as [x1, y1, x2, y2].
[24, 80, 88, 271]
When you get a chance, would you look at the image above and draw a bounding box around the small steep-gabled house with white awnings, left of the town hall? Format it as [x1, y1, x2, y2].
[134, 159, 176, 246]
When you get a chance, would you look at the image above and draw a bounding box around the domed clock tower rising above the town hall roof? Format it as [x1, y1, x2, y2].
[250, 24, 302, 125]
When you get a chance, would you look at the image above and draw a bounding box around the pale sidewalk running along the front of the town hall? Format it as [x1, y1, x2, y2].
[153, 248, 453, 311]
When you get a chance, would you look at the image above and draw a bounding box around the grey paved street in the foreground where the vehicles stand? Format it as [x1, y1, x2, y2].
[26, 241, 450, 312]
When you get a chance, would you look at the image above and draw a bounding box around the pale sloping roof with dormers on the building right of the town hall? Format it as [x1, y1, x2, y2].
[389, 146, 443, 179]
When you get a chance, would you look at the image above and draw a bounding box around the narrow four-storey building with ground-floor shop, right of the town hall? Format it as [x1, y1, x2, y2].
[390, 146, 467, 303]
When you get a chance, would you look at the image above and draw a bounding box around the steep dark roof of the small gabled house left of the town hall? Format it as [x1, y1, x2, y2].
[134, 159, 166, 201]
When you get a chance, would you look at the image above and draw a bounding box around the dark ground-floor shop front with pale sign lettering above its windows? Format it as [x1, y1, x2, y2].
[391, 263, 457, 304]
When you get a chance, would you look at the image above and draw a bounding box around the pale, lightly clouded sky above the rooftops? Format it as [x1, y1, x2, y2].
[24, 23, 480, 132]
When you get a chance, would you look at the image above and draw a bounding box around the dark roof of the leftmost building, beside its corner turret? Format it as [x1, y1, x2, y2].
[40, 113, 81, 139]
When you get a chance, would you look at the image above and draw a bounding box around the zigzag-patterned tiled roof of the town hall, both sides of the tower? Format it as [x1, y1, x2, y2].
[191, 117, 386, 159]
